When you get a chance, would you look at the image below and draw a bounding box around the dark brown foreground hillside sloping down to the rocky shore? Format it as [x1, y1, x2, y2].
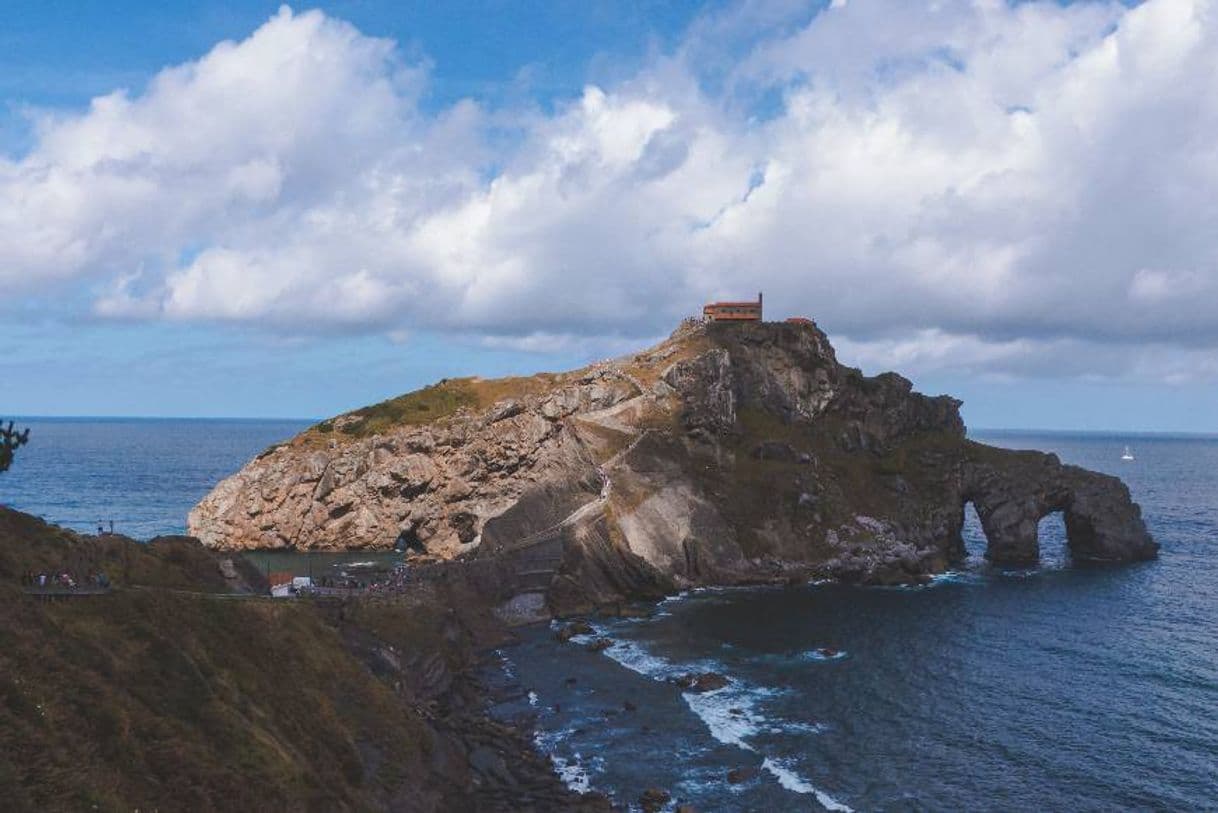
[0, 508, 602, 811]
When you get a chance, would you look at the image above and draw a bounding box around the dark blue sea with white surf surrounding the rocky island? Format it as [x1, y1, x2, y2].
[0, 419, 1218, 811]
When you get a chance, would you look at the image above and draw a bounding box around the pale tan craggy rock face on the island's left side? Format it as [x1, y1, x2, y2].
[189, 374, 637, 557]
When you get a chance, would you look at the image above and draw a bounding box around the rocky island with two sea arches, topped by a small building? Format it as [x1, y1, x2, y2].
[190, 323, 1157, 609]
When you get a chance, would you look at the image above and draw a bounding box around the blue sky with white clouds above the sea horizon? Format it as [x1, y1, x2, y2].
[0, 0, 1218, 431]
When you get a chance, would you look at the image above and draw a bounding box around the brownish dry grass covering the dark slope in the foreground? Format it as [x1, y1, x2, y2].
[0, 509, 448, 811]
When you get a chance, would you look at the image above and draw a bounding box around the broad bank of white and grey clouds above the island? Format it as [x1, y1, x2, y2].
[0, 0, 1218, 377]
